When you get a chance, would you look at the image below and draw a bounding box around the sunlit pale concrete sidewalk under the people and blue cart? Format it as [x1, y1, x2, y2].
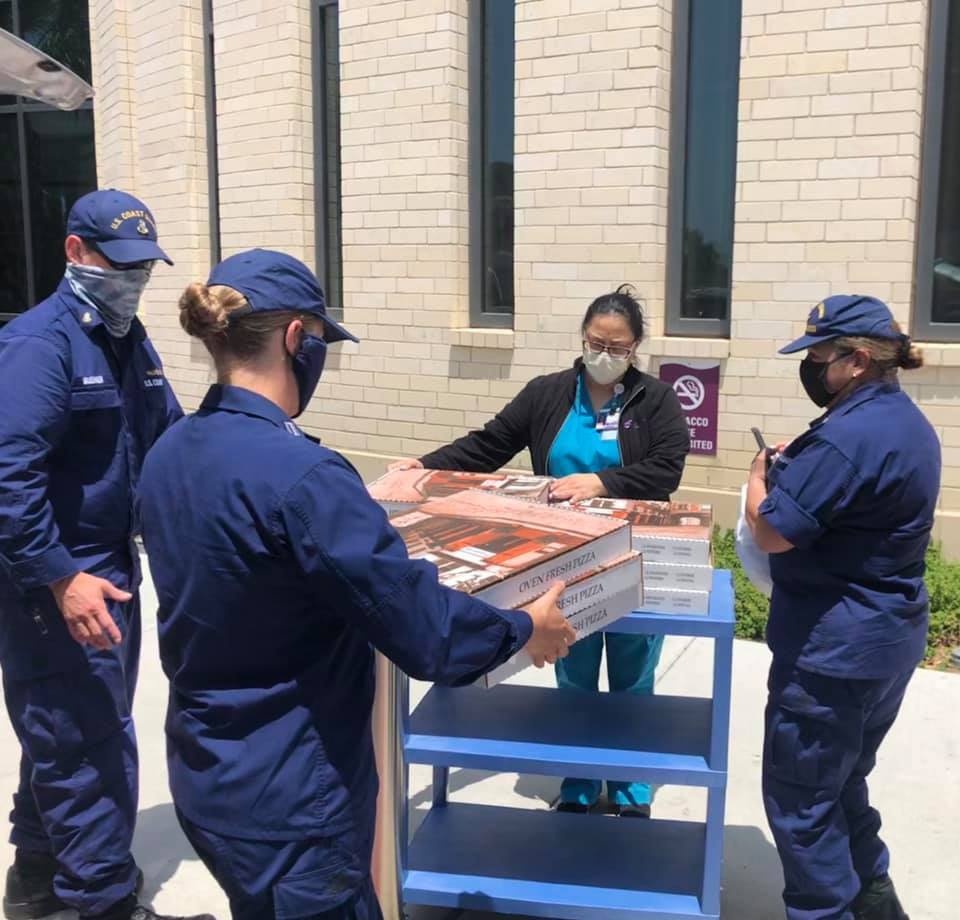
[0, 560, 960, 920]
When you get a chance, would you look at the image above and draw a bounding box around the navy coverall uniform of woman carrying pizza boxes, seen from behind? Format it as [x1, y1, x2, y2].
[140, 385, 532, 920]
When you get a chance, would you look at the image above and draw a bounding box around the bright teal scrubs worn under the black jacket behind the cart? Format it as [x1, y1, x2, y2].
[547, 371, 663, 806]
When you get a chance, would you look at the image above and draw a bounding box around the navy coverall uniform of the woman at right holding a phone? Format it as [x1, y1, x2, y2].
[760, 381, 940, 920]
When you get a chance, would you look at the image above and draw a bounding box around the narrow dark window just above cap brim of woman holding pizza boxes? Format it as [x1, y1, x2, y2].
[313, 0, 343, 319]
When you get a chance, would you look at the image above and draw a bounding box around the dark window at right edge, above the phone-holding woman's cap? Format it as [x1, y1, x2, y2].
[913, 0, 960, 342]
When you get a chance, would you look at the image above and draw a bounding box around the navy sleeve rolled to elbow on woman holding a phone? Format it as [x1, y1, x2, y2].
[760, 441, 859, 549]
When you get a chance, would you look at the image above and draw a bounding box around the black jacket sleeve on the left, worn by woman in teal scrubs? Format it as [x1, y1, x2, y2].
[420, 383, 536, 473]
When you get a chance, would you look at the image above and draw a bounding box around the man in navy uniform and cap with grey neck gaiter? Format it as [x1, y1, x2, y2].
[0, 190, 212, 920]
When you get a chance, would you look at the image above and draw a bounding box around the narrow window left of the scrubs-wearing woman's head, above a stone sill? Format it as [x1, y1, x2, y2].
[470, 0, 516, 328]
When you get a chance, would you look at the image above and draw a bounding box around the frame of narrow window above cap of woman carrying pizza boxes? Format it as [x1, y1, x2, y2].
[310, 0, 343, 320]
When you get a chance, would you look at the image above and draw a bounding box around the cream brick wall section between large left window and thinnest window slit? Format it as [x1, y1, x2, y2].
[90, 0, 216, 407]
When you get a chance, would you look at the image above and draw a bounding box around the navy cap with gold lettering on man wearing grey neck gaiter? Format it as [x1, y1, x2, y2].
[67, 188, 173, 265]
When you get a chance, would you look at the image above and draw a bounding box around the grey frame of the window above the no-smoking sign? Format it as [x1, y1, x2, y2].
[664, 0, 743, 339]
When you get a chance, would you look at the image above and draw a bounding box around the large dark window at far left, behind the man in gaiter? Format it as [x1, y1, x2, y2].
[0, 0, 97, 322]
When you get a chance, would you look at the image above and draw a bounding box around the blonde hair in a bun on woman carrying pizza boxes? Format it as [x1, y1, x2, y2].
[180, 282, 302, 368]
